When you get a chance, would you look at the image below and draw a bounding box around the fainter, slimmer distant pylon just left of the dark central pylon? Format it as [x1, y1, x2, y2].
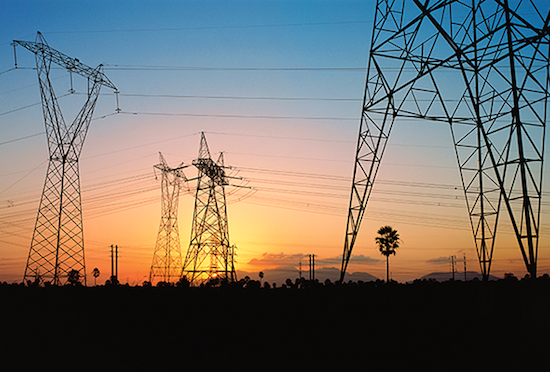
[149, 152, 187, 283]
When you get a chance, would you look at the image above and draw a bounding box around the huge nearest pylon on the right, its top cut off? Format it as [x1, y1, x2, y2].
[341, 0, 550, 280]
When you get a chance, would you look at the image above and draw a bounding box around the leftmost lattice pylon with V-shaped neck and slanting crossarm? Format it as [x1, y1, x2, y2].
[14, 33, 117, 285]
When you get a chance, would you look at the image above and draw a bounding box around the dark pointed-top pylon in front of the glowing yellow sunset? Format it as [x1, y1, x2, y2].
[182, 133, 236, 283]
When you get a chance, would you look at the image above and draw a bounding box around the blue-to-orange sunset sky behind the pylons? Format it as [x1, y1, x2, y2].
[0, 0, 550, 284]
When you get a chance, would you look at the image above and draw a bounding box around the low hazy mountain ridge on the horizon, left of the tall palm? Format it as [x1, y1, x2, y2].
[237, 266, 378, 286]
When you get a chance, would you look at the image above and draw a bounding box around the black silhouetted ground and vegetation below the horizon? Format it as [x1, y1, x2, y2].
[0, 275, 550, 371]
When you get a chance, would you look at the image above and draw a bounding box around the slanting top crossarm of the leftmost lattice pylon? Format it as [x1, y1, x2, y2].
[13, 33, 117, 91]
